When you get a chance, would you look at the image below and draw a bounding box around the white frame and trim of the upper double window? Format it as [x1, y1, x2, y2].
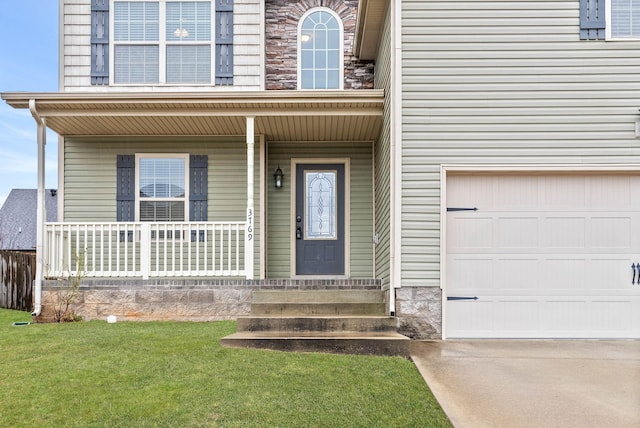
[109, 0, 216, 87]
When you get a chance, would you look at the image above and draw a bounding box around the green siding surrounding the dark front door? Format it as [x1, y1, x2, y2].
[266, 142, 373, 278]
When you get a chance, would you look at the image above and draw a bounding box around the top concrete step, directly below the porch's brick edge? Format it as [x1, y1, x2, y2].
[252, 290, 384, 303]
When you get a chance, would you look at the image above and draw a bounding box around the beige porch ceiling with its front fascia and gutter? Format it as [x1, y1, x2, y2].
[2, 90, 384, 141]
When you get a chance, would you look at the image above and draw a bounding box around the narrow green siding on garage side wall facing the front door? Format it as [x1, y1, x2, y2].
[375, 4, 391, 287]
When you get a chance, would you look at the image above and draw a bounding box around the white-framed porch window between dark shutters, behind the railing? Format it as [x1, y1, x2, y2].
[137, 155, 189, 222]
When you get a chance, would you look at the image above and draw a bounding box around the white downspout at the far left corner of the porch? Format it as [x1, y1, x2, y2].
[29, 99, 47, 317]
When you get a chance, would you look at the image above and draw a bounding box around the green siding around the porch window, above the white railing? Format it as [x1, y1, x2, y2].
[62, 137, 260, 275]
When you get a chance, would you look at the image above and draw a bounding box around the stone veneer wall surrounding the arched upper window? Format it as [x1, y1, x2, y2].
[265, 0, 374, 90]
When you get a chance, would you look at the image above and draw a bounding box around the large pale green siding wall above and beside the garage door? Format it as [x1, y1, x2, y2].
[402, 0, 640, 286]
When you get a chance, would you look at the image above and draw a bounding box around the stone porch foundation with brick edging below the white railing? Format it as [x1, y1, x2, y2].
[36, 279, 380, 322]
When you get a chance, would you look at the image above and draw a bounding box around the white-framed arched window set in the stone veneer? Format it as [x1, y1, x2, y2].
[298, 8, 344, 89]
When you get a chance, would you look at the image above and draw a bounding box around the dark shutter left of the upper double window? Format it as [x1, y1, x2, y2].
[91, 0, 109, 85]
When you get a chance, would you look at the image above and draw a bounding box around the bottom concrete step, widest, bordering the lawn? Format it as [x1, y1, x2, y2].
[221, 332, 411, 358]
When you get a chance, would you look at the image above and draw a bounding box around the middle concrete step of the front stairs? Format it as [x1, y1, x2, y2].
[238, 316, 398, 335]
